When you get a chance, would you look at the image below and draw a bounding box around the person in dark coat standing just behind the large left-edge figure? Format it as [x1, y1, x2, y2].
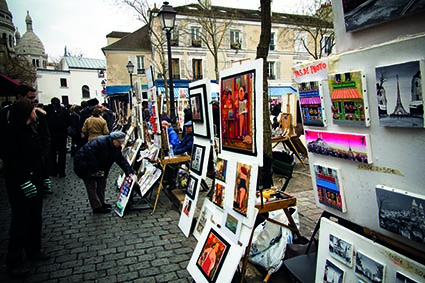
[45, 97, 72, 178]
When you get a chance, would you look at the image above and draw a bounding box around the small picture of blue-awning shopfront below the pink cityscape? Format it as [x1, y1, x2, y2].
[314, 164, 346, 212]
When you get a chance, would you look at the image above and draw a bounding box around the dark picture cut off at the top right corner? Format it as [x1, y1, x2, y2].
[342, 0, 425, 31]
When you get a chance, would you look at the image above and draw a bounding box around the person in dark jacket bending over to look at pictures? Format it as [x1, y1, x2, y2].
[74, 132, 132, 214]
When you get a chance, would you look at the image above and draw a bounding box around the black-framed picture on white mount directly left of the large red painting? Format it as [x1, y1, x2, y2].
[189, 79, 212, 139]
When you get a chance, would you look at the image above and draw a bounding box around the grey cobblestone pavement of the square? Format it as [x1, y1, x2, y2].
[0, 156, 320, 283]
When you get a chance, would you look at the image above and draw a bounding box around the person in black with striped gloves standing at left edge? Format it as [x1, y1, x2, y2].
[0, 100, 50, 276]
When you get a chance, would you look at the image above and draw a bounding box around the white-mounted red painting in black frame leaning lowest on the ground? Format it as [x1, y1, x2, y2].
[187, 223, 244, 283]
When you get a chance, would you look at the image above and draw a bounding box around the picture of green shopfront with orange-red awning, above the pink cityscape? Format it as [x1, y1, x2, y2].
[328, 71, 370, 127]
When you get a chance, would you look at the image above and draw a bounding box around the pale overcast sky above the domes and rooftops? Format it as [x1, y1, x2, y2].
[6, 0, 317, 61]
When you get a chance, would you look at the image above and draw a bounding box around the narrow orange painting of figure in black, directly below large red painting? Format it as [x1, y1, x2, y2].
[233, 162, 251, 216]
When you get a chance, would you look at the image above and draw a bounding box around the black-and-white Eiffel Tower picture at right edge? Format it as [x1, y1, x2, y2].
[375, 61, 424, 128]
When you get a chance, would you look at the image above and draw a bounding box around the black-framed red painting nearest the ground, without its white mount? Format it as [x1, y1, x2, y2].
[196, 228, 230, 282]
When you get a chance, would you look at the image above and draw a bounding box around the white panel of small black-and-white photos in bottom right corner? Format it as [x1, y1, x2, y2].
[315, 218, 425, 283]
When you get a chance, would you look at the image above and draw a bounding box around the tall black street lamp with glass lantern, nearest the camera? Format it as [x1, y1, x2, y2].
[158, 1, 177, 128]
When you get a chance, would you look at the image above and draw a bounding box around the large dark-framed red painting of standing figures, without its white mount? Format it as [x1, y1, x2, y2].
[220, 70, 257, 155]
